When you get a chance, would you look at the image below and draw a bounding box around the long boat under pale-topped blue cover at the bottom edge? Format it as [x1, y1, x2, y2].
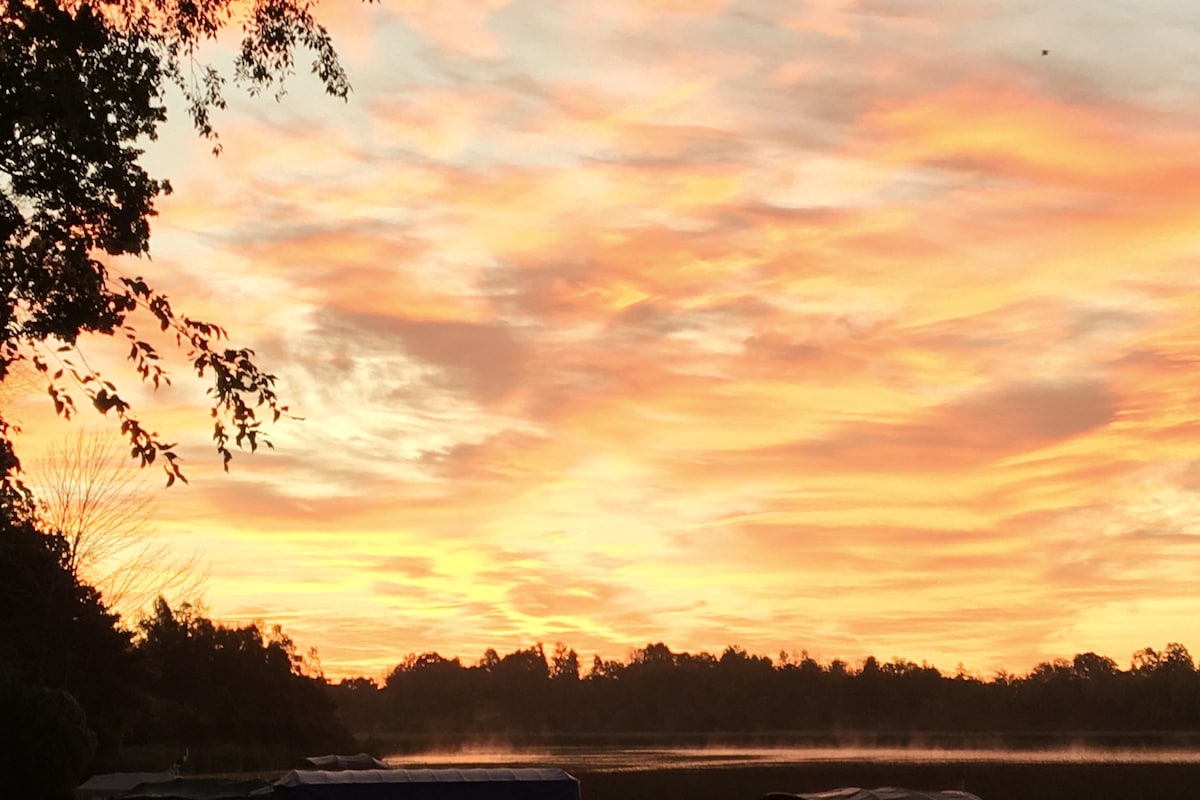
[275, 766, 580, 800]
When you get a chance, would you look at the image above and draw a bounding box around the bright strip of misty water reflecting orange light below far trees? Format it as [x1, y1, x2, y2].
[385, 747, 1200, 772]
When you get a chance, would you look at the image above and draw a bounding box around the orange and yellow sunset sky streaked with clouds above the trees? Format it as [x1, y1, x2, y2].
[6, 0, 1200, 678]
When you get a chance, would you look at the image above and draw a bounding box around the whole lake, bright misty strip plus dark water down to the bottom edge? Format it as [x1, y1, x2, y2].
[386, 746, 1200, 800]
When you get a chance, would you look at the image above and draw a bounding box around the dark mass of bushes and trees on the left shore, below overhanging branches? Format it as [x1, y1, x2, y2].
[0, 486, 350, 798]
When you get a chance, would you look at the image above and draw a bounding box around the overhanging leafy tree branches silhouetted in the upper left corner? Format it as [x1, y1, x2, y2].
[0, 0, 364, 483]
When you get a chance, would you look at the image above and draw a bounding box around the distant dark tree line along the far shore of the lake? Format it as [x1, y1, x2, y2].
[330, 643, 1200, 742]
